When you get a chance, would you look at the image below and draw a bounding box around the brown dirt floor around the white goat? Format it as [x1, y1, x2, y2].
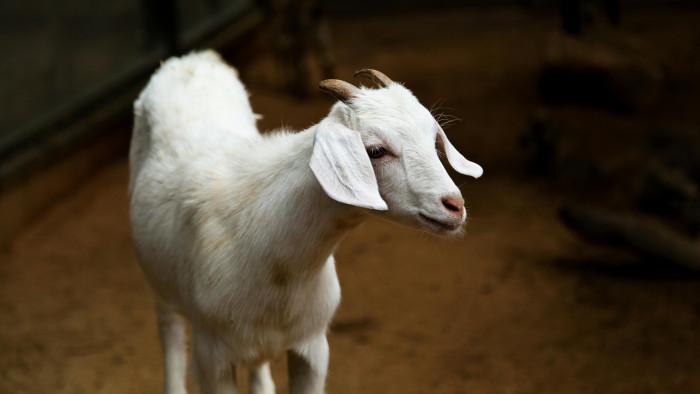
[0, 9, 700, 393]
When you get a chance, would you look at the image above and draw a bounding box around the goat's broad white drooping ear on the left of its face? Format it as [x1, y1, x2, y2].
[309, 120, 388, 210]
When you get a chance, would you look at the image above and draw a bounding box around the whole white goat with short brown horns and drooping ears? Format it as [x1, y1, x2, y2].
[129, 51, 482, 393]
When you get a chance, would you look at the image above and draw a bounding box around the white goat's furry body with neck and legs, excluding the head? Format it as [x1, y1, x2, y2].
[129, 51, 482, 393]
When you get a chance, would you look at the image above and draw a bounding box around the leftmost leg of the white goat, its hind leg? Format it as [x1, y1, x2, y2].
[156, 302, 187, 394]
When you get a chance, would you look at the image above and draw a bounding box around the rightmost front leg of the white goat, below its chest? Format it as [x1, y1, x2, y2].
[287, 332, 328, 394]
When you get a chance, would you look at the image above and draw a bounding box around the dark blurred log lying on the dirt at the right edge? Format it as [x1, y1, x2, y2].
[559, 205, 700, 270]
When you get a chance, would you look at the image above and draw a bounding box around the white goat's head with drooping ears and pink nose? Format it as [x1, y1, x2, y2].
[311, 74, 483, 234]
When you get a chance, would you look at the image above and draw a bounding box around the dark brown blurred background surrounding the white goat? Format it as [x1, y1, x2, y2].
[0, 0, 700, 393]
